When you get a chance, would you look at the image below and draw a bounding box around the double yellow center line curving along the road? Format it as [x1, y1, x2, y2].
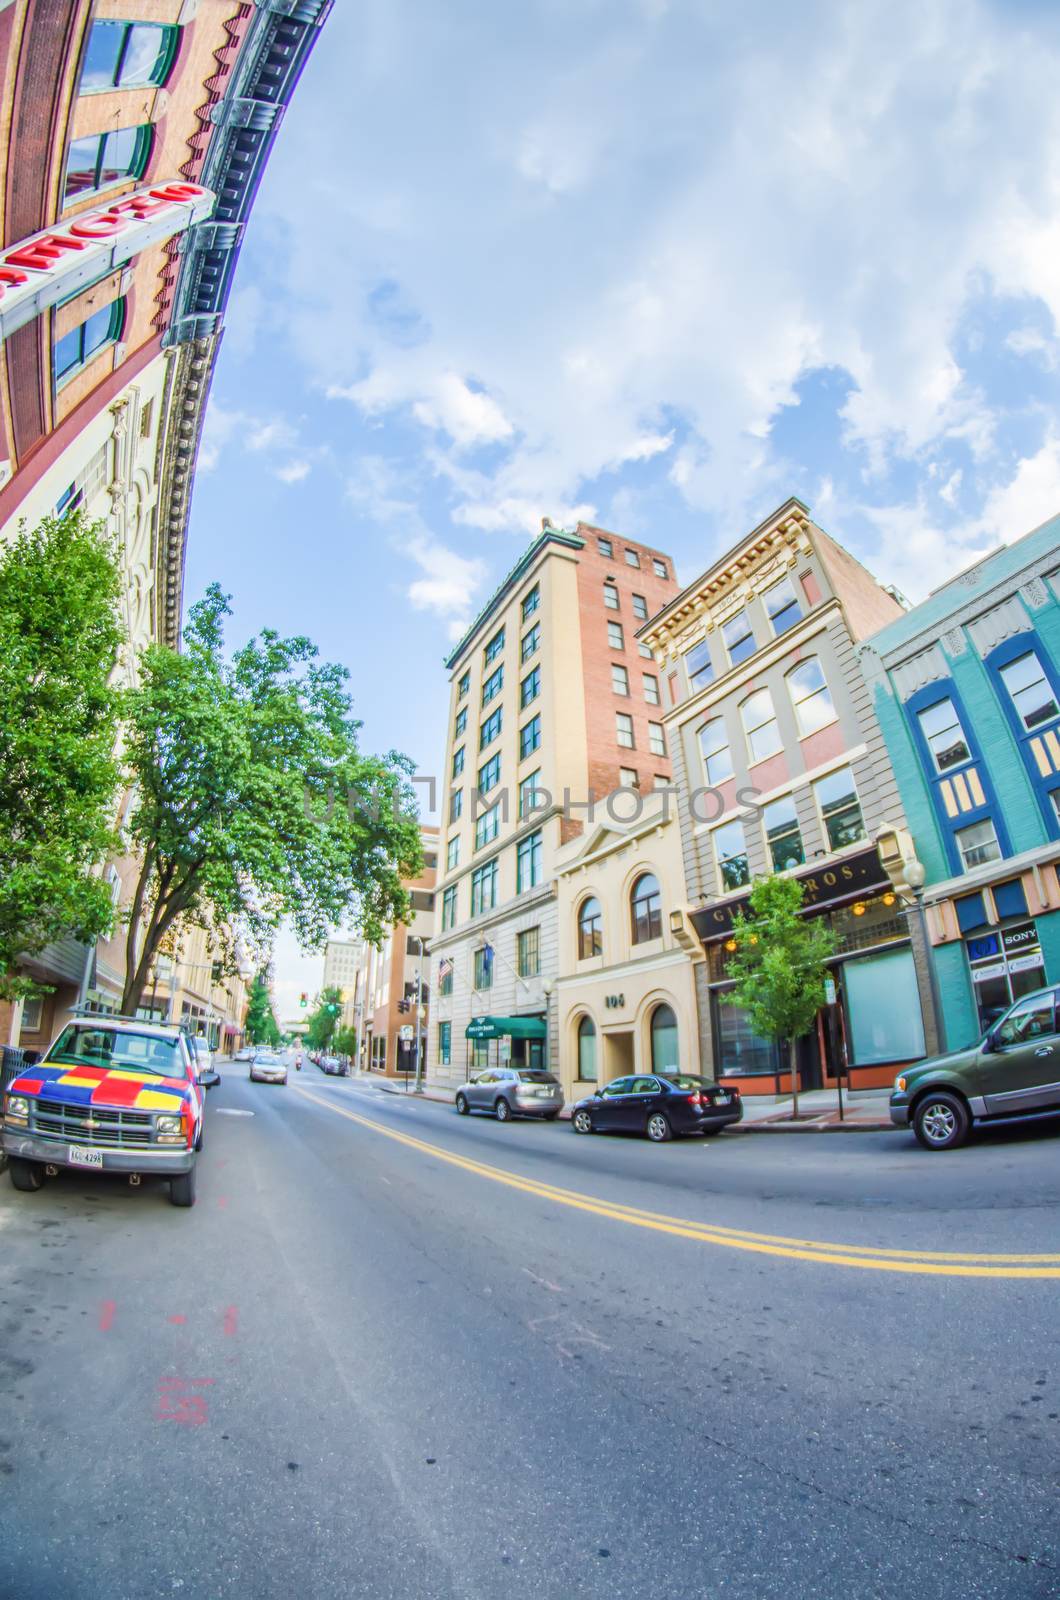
[298, 1088, 1060, 1278]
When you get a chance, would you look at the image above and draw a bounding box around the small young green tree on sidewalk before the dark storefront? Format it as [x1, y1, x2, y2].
[722, 877, 834, 1117]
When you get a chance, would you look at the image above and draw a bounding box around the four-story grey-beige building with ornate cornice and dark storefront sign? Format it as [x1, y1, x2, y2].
[639, 499, 934, 1094]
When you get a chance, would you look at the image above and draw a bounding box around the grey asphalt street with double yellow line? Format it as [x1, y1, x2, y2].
[0, 1066, 1060, 1600]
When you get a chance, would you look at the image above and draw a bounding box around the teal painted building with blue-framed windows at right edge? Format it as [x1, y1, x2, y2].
[860, 517, 1060, 1050]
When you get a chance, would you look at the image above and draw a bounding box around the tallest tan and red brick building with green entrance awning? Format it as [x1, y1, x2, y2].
[428, 520, 677, 1085]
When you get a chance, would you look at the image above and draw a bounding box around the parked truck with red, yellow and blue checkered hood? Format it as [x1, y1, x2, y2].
[3, 1016, 221, 1206]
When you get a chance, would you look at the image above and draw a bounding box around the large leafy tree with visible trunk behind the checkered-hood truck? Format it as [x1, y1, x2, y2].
[122, 586, 421, 1011]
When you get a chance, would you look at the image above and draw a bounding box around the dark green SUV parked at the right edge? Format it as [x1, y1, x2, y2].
[890, 989, 1060, 1150]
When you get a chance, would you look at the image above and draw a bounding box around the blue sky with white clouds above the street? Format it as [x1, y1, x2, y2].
[187, 0, 1060, 989]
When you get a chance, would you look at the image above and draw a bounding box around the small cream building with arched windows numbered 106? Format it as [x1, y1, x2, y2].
[556, 790, 703, 1101]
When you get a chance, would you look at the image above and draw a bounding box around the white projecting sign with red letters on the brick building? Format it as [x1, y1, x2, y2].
[0, 182, 215, 341]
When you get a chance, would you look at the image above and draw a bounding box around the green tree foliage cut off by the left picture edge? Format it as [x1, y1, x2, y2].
[0, 512, 123, 997]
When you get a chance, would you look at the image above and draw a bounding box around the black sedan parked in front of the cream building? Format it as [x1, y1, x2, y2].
[570, 1072, 743, 1144]
